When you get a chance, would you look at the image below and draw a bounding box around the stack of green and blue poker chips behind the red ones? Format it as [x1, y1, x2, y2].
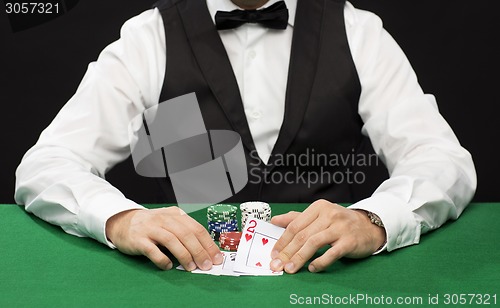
[207, 204, 238, 241]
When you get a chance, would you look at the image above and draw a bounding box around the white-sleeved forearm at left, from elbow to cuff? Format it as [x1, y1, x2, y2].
[15, 147, 142, 247]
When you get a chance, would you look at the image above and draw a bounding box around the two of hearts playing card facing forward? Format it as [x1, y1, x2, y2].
[233, 219, 285, 275]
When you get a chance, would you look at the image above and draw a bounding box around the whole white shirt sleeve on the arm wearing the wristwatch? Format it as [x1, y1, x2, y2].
[346, 4, 476, 251]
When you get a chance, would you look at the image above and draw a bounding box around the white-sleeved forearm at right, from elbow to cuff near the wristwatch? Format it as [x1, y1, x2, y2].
[350, 151, 476, 251]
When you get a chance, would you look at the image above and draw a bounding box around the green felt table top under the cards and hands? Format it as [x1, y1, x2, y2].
[0, 203, 500, 307]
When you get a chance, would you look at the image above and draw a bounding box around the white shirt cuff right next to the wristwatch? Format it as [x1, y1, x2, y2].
[349, 192, 420, 254]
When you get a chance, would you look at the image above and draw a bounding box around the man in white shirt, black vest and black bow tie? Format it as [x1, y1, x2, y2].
[15, 0, 476, 273]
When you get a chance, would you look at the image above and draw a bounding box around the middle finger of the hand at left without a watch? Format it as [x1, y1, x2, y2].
[168, 219, 213, 271]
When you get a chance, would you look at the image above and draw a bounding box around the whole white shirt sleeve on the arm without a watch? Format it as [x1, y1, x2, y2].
[15, 10, 166, 247]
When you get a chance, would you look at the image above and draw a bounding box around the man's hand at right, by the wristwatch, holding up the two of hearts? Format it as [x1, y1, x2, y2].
[271, 200, 386, 274]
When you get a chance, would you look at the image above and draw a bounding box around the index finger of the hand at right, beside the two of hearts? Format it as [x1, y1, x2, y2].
[271, 208, 318, 263]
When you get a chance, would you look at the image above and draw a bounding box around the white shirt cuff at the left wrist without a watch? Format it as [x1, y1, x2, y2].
[78, 193, 144, 249]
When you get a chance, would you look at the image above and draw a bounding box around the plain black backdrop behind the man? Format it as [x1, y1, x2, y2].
[0, 0, 500, 203]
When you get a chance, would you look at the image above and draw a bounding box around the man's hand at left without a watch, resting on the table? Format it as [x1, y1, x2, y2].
[106, 207, 222, 271]
